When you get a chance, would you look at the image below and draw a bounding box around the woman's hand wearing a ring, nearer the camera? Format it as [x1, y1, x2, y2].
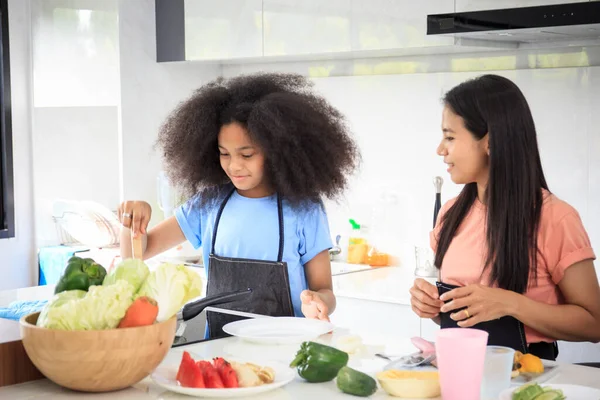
[441, 284, 519, 328]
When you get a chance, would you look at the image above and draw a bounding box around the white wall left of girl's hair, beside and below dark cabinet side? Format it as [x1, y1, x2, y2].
[119, 0, 221, 223]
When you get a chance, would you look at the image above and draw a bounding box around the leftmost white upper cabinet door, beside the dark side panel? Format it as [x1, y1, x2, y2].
[185, 0, 263, 60]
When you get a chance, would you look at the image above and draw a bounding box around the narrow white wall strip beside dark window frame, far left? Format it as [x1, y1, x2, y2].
[0, 0, 37, 290]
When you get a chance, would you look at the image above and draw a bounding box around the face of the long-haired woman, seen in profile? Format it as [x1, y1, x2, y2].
[437, 106, 490, 186]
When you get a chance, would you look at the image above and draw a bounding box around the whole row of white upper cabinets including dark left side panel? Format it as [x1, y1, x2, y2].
[155, 0, 516, 63]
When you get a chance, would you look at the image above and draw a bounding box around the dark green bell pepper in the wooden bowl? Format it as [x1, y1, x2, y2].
[54, 256, 106, 293]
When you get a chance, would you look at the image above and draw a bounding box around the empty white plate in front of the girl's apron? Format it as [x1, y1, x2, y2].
[223, 317, 334, 344]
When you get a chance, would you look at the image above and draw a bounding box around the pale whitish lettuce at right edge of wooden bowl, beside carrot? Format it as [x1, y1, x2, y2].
[137, 263, 202, 322]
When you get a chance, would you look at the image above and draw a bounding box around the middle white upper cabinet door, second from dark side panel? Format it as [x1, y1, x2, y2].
[263, 0, 352, 56]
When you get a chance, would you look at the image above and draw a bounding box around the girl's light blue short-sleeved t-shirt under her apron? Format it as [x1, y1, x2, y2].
[175, 191, 332, 317]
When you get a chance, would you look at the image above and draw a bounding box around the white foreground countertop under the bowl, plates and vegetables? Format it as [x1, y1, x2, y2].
[0, 333, 600, 400]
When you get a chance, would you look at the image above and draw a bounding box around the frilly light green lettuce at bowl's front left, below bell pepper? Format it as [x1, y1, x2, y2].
[38, 279, 135, 330]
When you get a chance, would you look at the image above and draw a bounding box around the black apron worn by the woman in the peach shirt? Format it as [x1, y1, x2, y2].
[436, 282, 558, 360]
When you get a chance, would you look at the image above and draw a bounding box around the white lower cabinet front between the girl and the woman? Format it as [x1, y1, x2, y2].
[331, 296, 420, 338]
